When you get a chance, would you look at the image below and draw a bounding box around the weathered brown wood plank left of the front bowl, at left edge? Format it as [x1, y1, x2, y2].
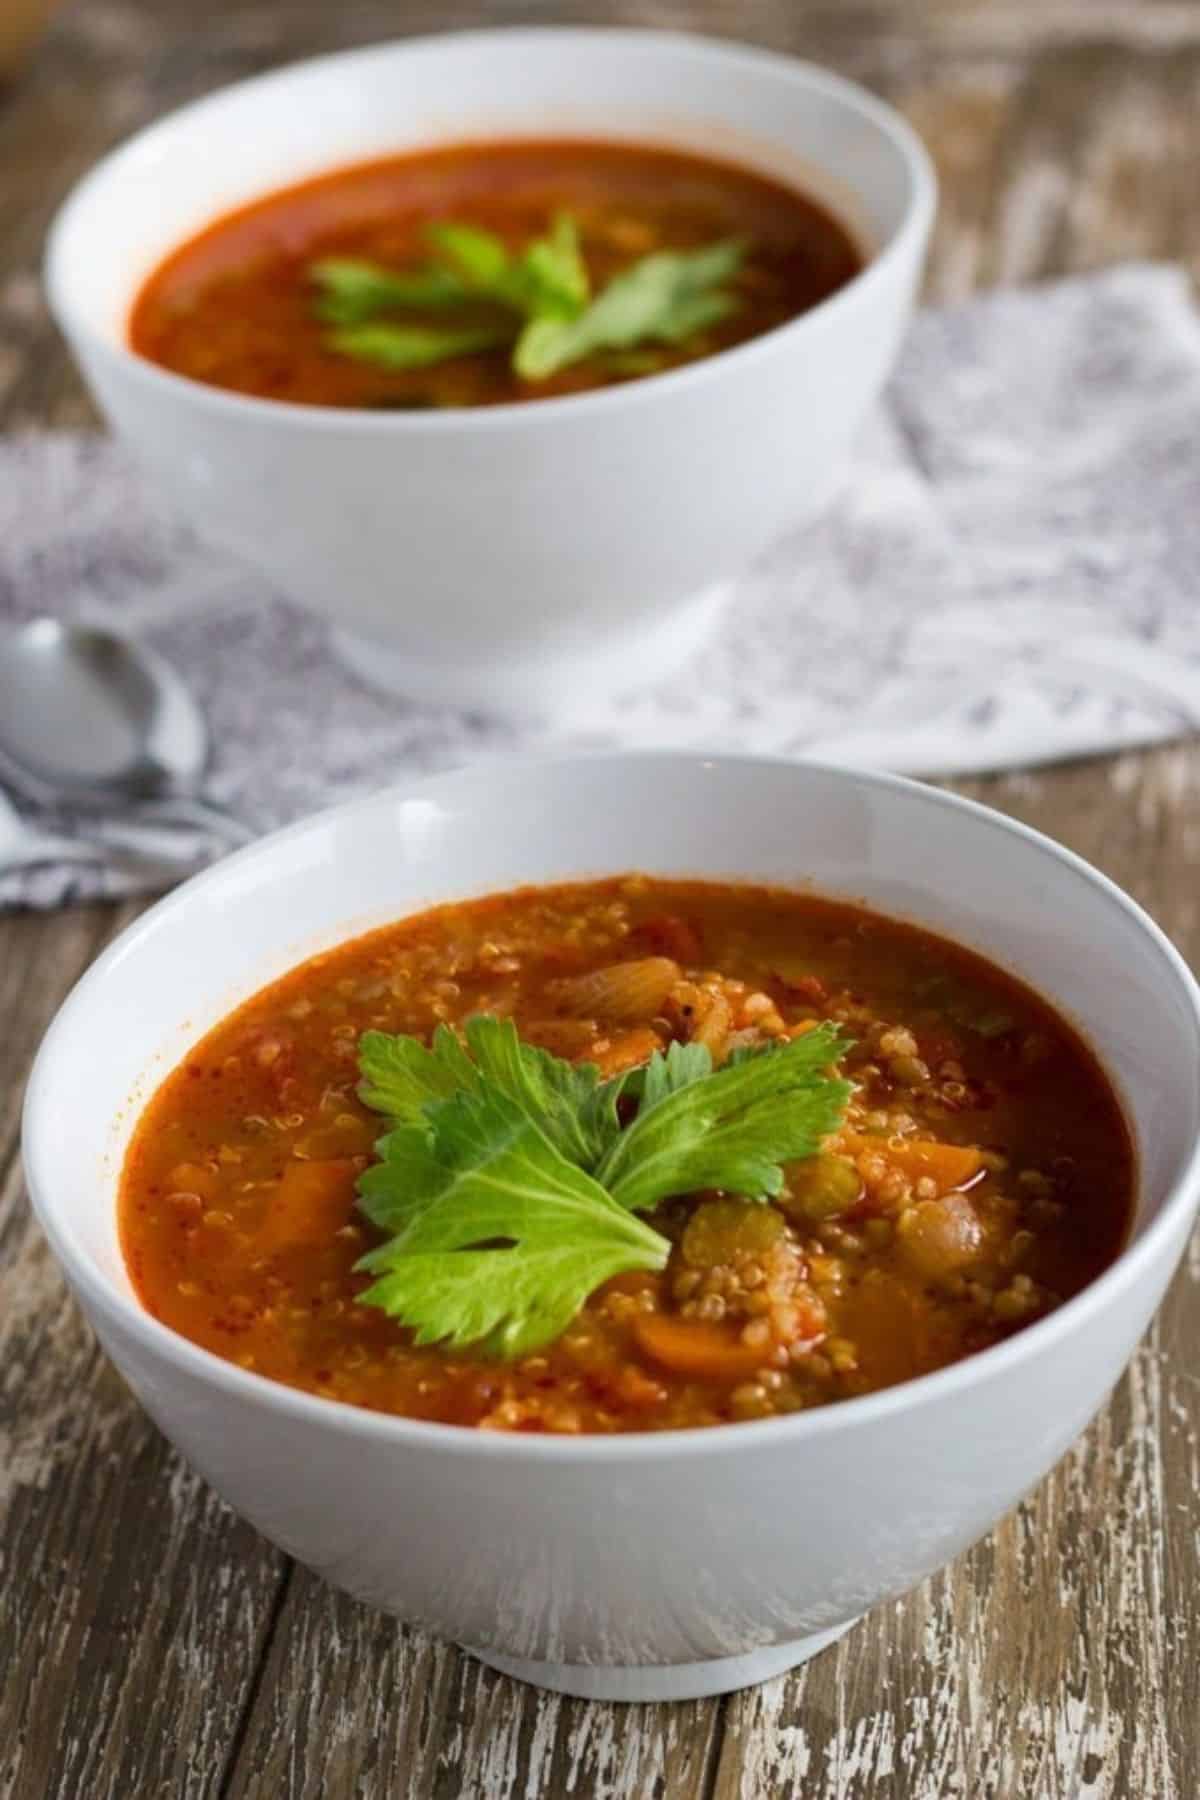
[0, 909, 282, 1800]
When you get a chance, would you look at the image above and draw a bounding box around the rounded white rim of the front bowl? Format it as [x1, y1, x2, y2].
[22, 751, 1200, 1463]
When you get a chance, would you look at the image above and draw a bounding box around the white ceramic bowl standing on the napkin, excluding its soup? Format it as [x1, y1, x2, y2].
[47, 29, 934, 709]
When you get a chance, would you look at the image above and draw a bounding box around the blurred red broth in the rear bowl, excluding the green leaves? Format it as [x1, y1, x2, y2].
[130, 140, 864, 409]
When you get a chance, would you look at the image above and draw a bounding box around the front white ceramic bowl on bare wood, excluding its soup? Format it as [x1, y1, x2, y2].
[25, 756, 1200, 1699]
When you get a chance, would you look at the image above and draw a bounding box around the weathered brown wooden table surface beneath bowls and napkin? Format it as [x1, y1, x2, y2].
[0, 0, 1200, 1800]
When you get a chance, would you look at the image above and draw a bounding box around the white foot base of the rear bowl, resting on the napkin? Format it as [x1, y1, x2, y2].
[331, 583, 732, 718]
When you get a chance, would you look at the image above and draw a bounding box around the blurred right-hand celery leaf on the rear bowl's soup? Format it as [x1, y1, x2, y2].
[513, 238, 745, 382]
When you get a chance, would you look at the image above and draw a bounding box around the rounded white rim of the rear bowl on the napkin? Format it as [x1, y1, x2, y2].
[43, 25, 937, 437]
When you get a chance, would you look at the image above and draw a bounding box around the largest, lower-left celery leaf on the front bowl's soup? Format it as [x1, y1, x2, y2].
[358, 1085, 671, 1357]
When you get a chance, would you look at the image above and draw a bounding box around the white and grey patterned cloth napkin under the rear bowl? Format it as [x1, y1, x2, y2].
[0, 265, 1200, 905]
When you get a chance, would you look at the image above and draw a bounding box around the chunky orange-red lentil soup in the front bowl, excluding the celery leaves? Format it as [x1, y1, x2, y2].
[121, 875, 1133, 1433]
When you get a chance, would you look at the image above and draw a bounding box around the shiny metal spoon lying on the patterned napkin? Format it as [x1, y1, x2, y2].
[0, 619, 254, 848]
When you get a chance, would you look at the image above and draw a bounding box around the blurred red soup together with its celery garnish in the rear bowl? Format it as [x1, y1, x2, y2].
[130, 140, 864, 410]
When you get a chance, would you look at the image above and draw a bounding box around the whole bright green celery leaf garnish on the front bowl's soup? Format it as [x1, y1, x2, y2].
[358, 1015, 849, 1357]
